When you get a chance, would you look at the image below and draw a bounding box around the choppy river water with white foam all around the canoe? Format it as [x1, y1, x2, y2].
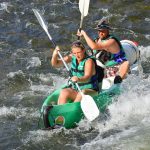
[0, 0, 150, 150]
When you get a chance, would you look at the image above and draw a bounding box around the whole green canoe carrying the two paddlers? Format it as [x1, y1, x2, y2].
[41, 85, 119, 129]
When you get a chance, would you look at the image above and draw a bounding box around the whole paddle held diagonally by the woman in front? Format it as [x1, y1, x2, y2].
[33, 9, 99, 121]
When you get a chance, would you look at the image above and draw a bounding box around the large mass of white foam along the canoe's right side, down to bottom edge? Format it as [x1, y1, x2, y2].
[78, 76, 150, 150]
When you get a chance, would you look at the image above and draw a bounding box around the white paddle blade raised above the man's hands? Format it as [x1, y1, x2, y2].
[79, 0, 90, 17]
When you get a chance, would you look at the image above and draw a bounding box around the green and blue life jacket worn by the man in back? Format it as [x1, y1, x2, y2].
[94, 35, 127, 67]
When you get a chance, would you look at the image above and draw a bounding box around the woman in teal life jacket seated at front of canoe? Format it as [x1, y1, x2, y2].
[51, 41, 104, 105]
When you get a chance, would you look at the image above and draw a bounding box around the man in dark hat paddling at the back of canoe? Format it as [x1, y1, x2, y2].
[77, 20, 129, 84]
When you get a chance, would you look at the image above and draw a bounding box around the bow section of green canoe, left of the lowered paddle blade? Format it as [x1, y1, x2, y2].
[41, 86, 84, 128]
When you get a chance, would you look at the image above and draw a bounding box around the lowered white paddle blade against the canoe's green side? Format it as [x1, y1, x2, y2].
[81, 95, 100, 121]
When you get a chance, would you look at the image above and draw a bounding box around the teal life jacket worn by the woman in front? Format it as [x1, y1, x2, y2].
[70, 56, 102, 91]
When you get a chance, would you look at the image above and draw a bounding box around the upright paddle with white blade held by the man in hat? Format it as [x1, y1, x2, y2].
[78, 0, 90, 40]
